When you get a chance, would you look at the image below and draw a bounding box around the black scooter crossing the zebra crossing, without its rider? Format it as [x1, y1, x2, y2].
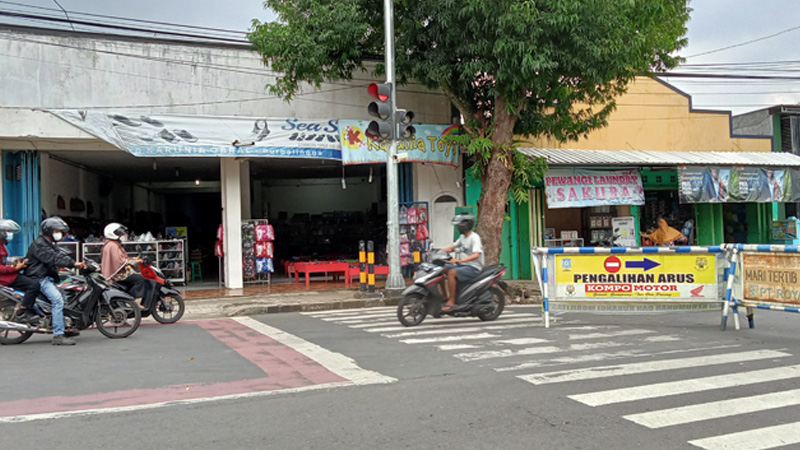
[397, 250, 507, 327]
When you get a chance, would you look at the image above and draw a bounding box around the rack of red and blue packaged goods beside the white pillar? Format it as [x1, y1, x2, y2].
[242, 219, 275, 284]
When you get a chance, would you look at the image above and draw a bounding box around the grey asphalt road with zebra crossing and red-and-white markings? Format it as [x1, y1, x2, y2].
[0, 307, 800, 450]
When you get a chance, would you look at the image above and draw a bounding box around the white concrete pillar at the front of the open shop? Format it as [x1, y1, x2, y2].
[219, 158, 244, 289]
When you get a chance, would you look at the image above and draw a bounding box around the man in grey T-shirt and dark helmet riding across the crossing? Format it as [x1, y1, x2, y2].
[442, 213, 483, 311]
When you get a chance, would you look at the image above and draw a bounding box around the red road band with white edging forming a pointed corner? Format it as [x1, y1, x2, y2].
[0, 317, 397, 423]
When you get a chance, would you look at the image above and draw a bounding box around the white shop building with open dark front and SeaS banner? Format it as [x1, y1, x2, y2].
[0, 26, 464, 288]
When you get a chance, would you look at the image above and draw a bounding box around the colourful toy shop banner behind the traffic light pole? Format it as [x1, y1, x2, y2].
[339, 120, 458, 166]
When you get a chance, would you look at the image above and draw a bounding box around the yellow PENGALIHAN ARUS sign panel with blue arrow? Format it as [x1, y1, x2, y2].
[555, 254, 717, 300]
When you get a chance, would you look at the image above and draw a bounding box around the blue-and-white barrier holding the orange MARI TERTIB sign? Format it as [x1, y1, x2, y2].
[722, 244, 800, 330]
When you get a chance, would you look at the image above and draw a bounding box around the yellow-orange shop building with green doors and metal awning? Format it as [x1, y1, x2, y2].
[466, 77, 800, 280]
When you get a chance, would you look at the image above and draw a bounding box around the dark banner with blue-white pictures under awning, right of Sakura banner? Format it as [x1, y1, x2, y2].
[678, 166, 800, 203]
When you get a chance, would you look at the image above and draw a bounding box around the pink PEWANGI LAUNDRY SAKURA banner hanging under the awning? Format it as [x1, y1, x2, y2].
[544, 169, 644, 209]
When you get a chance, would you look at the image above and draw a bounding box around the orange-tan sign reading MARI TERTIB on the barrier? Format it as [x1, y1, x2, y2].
[742, 253, 800, 304]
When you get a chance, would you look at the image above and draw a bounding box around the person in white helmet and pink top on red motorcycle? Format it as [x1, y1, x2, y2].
[100, 222, 156, 310]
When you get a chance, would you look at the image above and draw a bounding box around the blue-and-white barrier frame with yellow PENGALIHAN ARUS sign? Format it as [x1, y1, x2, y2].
[533, 246, 733, 328]
